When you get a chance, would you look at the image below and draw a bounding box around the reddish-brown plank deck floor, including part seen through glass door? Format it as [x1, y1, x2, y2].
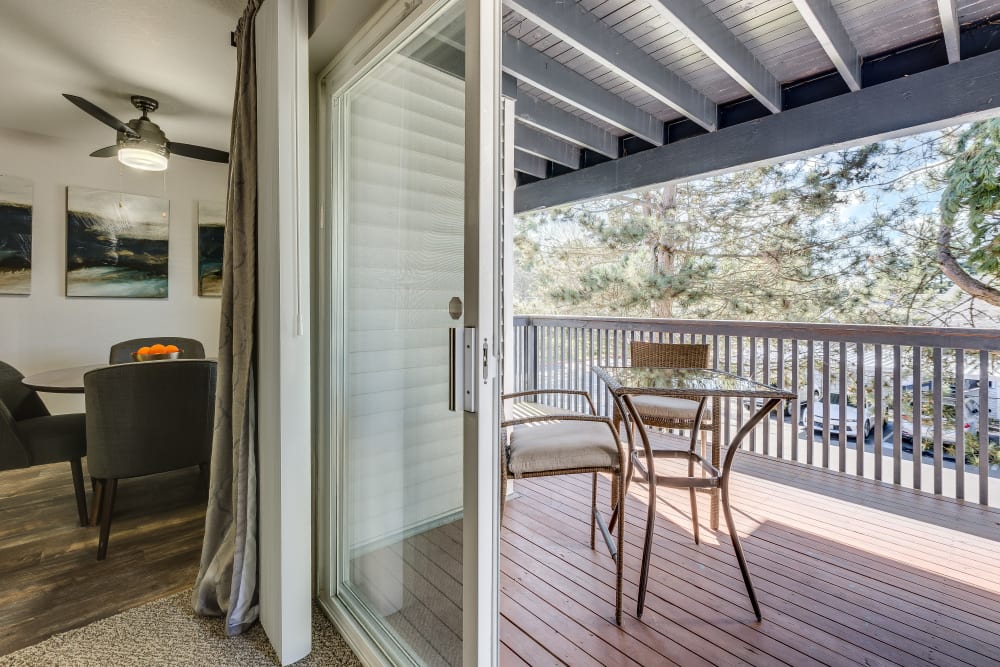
[358, 438, 1000, 667]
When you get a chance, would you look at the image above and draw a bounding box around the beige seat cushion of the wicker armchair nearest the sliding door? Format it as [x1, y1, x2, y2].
[508, 420, 619, 477]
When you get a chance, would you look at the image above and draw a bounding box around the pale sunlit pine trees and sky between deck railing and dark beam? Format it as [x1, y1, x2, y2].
[515, 121, 1000, 325]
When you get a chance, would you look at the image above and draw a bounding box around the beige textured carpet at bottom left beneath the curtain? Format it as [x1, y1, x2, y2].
[0, 591, 361, 667]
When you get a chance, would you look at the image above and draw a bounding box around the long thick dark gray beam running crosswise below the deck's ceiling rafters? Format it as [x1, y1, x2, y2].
[514, 51, 1000, 212]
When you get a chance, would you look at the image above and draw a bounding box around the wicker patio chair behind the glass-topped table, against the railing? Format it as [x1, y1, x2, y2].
[612, 341, 722, 528]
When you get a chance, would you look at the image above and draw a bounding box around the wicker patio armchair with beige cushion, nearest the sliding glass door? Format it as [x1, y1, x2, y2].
[500, 389, 626, 625]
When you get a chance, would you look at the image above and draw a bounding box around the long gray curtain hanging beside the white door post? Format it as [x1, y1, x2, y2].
[193, 0, 263, 635]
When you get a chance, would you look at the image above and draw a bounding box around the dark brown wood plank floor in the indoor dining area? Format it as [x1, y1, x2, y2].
[0, 463, 207, 655]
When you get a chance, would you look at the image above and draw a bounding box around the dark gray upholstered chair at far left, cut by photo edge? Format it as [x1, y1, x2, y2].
[0, 361, 87, 526]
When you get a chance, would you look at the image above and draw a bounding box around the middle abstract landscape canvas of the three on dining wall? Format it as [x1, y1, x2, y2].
[66, 186, 170, 298]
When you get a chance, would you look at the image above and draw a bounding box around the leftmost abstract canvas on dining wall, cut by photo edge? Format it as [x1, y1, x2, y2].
[0, 174, 32, 294]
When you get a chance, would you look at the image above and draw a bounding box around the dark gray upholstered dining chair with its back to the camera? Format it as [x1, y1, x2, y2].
[83, 359, 216, 560]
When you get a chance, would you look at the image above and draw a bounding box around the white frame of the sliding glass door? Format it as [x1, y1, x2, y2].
[314, 0, 501, 665]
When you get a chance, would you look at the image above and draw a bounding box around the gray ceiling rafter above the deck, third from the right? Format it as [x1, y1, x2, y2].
[649, 0, 781, 113]
